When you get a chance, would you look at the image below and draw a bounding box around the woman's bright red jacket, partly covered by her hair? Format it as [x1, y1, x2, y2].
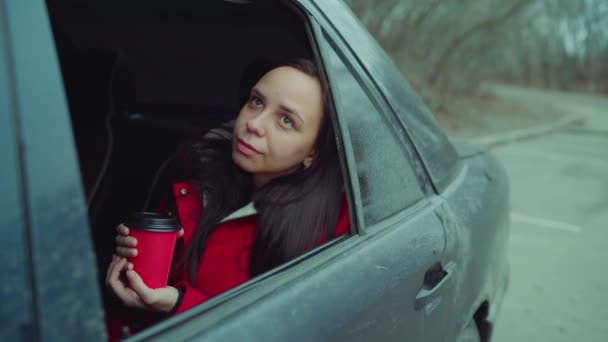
[173, 183, 350, 314]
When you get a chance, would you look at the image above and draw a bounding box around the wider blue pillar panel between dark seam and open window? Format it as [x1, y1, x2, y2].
[0, 0, 106, 341]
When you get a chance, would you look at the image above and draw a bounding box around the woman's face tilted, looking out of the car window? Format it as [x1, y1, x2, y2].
[232, 66, 323, 187]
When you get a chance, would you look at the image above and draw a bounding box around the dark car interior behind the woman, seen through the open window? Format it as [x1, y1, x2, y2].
[47, 0, 320, 332]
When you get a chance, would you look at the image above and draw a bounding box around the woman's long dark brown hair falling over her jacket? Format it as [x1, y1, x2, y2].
[184, 59, 343, 283]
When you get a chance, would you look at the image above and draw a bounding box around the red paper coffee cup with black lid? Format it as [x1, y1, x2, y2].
[124, 212, 180, 289]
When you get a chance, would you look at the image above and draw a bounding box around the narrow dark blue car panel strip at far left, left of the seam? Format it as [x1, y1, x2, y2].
[0, 1, 38, 340]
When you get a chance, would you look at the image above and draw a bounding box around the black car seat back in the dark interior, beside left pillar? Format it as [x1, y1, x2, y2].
[61, 50, 135, 206]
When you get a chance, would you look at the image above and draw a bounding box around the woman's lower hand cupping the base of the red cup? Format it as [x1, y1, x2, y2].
[106, 255, 179, 312]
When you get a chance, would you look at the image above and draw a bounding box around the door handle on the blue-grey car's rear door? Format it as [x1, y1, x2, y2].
[414, 262, 455, 310]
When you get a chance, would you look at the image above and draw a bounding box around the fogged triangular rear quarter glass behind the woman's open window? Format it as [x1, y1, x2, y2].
[324, 36, 422, 226]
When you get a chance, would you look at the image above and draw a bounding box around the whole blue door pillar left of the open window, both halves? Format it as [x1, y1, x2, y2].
[0, 0, 105, 341]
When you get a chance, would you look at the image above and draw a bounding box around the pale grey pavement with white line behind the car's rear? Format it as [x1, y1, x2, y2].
[492, 129, 608, 342]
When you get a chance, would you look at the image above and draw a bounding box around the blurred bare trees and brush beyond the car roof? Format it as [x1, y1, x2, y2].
[346, 0, 608, 111]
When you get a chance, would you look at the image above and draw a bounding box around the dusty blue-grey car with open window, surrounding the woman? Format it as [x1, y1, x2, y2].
[0, 0, 509, 341]
